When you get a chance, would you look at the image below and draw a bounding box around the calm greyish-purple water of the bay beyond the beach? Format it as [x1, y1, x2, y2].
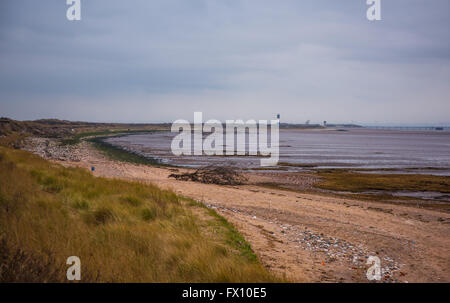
[103, 129, 450, 175]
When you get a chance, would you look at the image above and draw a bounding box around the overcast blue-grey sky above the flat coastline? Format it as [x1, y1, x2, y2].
[0, 0, 450, 125]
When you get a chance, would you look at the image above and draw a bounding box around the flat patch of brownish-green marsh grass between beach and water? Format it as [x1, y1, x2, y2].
[315, 169, 450, 193]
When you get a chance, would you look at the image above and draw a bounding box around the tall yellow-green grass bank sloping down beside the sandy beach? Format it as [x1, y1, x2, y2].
[0, 147, 278, 282]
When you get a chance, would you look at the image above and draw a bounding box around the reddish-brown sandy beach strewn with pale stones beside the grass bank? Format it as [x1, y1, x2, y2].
[53, 143, 450, 282]
